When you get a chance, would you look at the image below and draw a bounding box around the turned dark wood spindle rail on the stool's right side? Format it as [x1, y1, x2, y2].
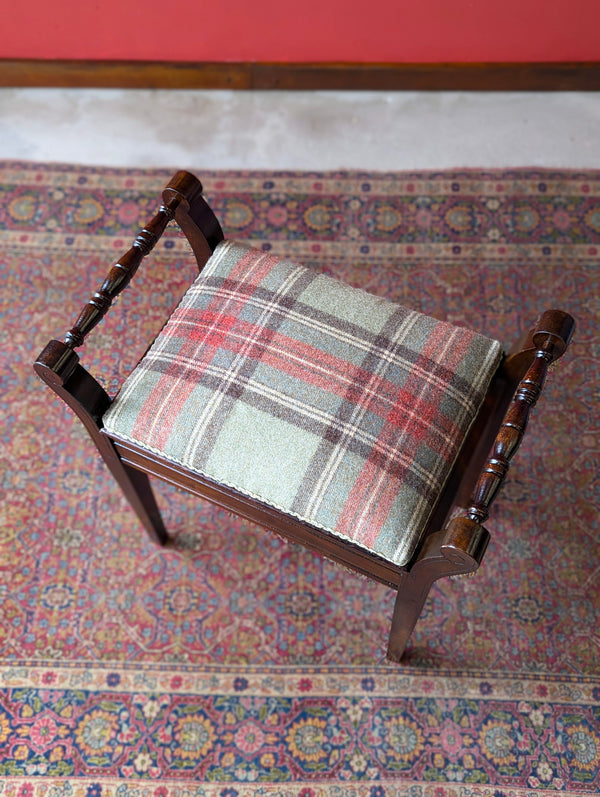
[467, 310, 574, 524]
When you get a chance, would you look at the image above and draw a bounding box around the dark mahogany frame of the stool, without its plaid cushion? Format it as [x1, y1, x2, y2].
[34, 172, 574, 661]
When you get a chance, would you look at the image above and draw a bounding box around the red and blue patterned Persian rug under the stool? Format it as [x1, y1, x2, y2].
[0, 162, 600, 797]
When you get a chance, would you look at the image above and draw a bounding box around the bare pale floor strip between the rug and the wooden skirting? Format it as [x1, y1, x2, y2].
[0, 89, 600, 170]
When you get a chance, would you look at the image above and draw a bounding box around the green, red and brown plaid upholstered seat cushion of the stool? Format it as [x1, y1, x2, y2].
[104, 242, 501, 565]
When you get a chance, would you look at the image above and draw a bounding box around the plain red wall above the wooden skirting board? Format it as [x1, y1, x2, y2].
[0, 0, 600, 63]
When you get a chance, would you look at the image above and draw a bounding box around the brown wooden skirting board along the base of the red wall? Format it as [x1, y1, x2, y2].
[0, 59, 600, 91]
